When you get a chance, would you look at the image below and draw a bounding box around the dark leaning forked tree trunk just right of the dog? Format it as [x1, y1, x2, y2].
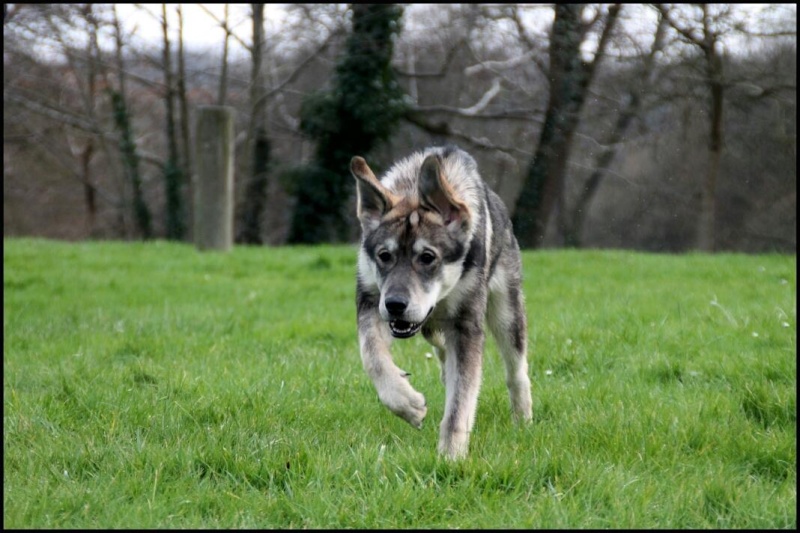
[512, 4, 620, 248]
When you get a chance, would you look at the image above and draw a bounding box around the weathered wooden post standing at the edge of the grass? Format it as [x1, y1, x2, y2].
[193, 106, 234, 251]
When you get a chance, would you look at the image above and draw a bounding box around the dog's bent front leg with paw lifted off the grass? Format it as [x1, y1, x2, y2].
[358, 295, 428, 428]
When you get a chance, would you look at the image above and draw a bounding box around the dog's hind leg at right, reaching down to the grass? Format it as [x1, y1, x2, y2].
[486, 268, 532, 422]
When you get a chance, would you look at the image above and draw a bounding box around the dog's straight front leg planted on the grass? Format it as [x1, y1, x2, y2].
[438, 317, 485, 459]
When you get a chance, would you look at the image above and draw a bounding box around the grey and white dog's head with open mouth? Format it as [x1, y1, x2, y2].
[350, 154, 471, 338]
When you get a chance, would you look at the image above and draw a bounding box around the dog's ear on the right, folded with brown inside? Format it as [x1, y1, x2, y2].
[419, 154, 470, 230]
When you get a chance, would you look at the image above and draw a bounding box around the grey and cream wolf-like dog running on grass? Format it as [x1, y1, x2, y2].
[350, 146, 531, 459]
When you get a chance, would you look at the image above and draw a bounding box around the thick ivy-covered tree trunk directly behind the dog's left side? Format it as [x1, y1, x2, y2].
[288, 4, 406, 243]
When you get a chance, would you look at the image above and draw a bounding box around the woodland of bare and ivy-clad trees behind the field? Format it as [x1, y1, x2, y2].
[3, 4, 797, 253]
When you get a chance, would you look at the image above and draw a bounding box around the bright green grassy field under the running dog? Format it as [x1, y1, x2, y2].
[3, 239, 797, 529]
